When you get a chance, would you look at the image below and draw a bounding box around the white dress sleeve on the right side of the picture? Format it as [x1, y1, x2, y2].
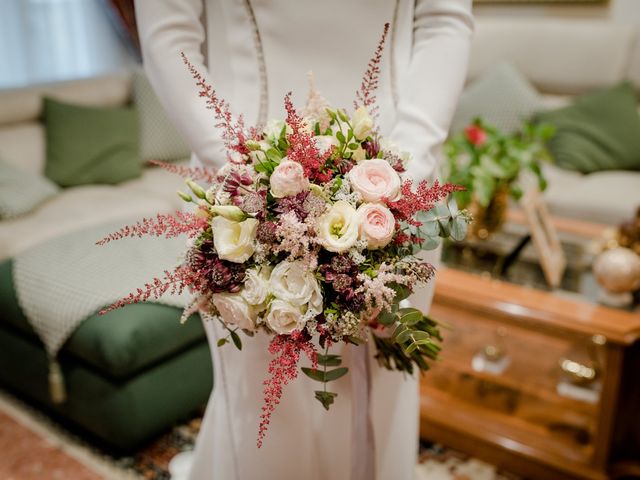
[391, 0, 473, 180]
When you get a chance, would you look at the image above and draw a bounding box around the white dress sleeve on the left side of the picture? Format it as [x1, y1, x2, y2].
[135, 0, 224, 167]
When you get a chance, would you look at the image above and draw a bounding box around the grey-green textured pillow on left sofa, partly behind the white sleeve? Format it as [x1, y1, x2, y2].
[133, 70, 191, 162]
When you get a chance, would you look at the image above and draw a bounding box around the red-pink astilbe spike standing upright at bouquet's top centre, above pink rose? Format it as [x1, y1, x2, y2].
[284, 92, 333, 182]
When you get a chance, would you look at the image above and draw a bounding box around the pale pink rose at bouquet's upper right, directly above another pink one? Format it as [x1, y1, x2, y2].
[349, 158, 401, 202]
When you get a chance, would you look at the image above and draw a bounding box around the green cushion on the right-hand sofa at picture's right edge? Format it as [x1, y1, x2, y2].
[537, 84, 640, 173]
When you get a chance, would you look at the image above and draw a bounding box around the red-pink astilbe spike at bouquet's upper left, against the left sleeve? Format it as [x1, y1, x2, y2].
[180, 52, 252, 155]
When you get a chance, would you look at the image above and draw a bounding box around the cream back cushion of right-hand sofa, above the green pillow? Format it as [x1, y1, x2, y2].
[469, 17, 637, 94]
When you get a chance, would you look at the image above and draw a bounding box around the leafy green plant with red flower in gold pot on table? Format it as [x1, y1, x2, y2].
[445, 118, 554, 239]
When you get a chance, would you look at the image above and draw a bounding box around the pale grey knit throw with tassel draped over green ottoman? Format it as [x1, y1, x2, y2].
[13, 219, 189, 402]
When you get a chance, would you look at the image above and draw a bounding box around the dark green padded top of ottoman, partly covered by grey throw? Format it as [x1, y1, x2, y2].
[0, 261, 205, 379]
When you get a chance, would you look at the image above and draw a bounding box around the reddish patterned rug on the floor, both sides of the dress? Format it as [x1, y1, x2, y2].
[0, 391, 522, 480]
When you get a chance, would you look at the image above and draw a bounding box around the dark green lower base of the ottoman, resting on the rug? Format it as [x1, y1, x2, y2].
[0, 325, 213, 451]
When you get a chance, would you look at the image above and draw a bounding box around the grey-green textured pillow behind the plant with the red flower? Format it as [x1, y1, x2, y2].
[451, 63, 543, 134]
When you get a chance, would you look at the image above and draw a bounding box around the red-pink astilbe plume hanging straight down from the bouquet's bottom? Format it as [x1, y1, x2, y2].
[257, 331, 318, 448]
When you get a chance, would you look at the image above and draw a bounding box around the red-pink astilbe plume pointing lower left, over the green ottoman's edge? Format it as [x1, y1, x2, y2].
[100, 266, 202, 315]
